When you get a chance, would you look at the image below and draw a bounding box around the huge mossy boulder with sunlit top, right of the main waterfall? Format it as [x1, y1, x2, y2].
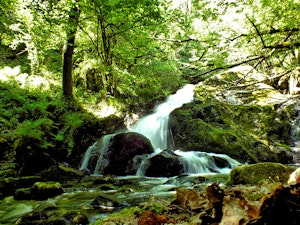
[169, 66, 294, 164]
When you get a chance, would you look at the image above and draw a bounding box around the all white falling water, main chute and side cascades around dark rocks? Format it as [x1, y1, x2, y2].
[80, 84, 240, 176]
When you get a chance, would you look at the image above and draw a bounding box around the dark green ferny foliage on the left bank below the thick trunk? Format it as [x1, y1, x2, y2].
[0, 81, 84, 163]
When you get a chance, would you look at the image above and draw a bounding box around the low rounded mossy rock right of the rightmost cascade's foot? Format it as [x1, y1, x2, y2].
[230, 162, 295, 184]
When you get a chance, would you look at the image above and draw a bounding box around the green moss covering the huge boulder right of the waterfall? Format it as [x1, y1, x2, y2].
[169, 83, 290, 163]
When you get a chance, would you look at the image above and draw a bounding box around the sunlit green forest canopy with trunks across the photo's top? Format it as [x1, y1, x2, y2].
[0, 0, 300, 104]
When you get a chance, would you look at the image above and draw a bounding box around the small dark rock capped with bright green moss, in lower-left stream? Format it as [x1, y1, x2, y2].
[30, 182, 64, 200]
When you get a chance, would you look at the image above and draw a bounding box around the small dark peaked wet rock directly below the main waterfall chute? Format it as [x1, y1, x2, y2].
[145, 150, 184, 177]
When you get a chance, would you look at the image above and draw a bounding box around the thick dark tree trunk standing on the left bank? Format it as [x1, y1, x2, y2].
[62, 5, 80, 102]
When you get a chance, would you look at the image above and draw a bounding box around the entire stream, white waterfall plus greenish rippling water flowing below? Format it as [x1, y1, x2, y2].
[0, 84, 240, 224]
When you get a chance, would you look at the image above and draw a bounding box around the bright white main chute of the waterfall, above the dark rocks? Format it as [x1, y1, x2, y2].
[128, 84, 194, 152]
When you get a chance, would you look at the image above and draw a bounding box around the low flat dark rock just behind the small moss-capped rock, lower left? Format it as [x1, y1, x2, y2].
[38, 164, 84, 182]
